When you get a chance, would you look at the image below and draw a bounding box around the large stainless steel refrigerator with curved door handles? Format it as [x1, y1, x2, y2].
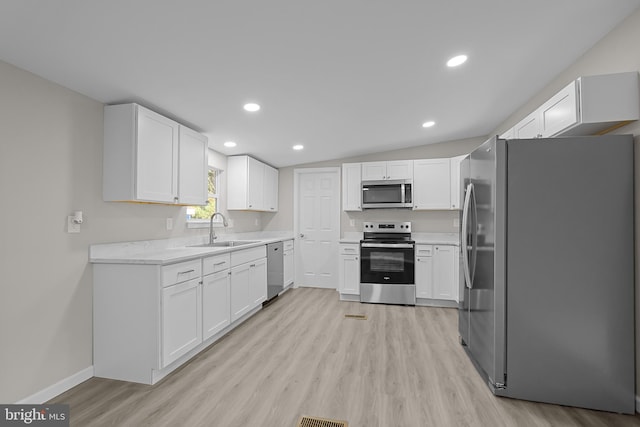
[459, 135, 635, 413]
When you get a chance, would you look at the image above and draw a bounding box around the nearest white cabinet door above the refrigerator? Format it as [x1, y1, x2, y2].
[539, 80, 578, 138]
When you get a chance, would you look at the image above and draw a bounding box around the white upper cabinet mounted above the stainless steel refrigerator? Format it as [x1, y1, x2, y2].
[500, 71, 640, 139]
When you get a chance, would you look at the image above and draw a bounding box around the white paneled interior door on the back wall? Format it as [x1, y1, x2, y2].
[294, 168, 340, 289]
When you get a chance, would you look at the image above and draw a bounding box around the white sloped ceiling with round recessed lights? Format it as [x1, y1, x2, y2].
[0, 0, 640, 167]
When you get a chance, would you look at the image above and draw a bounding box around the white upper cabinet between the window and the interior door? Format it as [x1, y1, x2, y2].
[227, 156, 278, 212]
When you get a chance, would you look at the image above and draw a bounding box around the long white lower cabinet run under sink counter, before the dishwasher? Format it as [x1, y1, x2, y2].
[93, 245, 267, 384]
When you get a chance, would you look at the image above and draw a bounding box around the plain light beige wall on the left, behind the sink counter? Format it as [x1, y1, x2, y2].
[0, 61, 260, 403]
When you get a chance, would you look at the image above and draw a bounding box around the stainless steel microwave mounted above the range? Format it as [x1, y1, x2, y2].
[362, 179, 413, 209]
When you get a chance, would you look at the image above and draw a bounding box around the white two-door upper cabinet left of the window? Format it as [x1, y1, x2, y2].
[103, 104, 207, 204]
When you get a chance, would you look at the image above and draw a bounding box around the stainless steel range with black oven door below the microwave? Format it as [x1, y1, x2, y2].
[360, 222, 416, 305]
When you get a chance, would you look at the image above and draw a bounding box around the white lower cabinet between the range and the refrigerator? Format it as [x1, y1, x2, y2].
[415, 244, 458, 305]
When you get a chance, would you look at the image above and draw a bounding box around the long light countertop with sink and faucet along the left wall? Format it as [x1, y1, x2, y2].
[89, 232, 293, 265]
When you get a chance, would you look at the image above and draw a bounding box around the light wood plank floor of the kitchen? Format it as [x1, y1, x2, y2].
[52, 288, 640, 427]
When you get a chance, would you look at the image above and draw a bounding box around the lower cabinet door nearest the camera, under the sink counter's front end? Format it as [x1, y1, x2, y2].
[162, 279, 202, 367]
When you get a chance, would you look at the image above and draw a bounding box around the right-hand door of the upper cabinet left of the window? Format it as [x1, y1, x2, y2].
[178, 126, 209, 205]
